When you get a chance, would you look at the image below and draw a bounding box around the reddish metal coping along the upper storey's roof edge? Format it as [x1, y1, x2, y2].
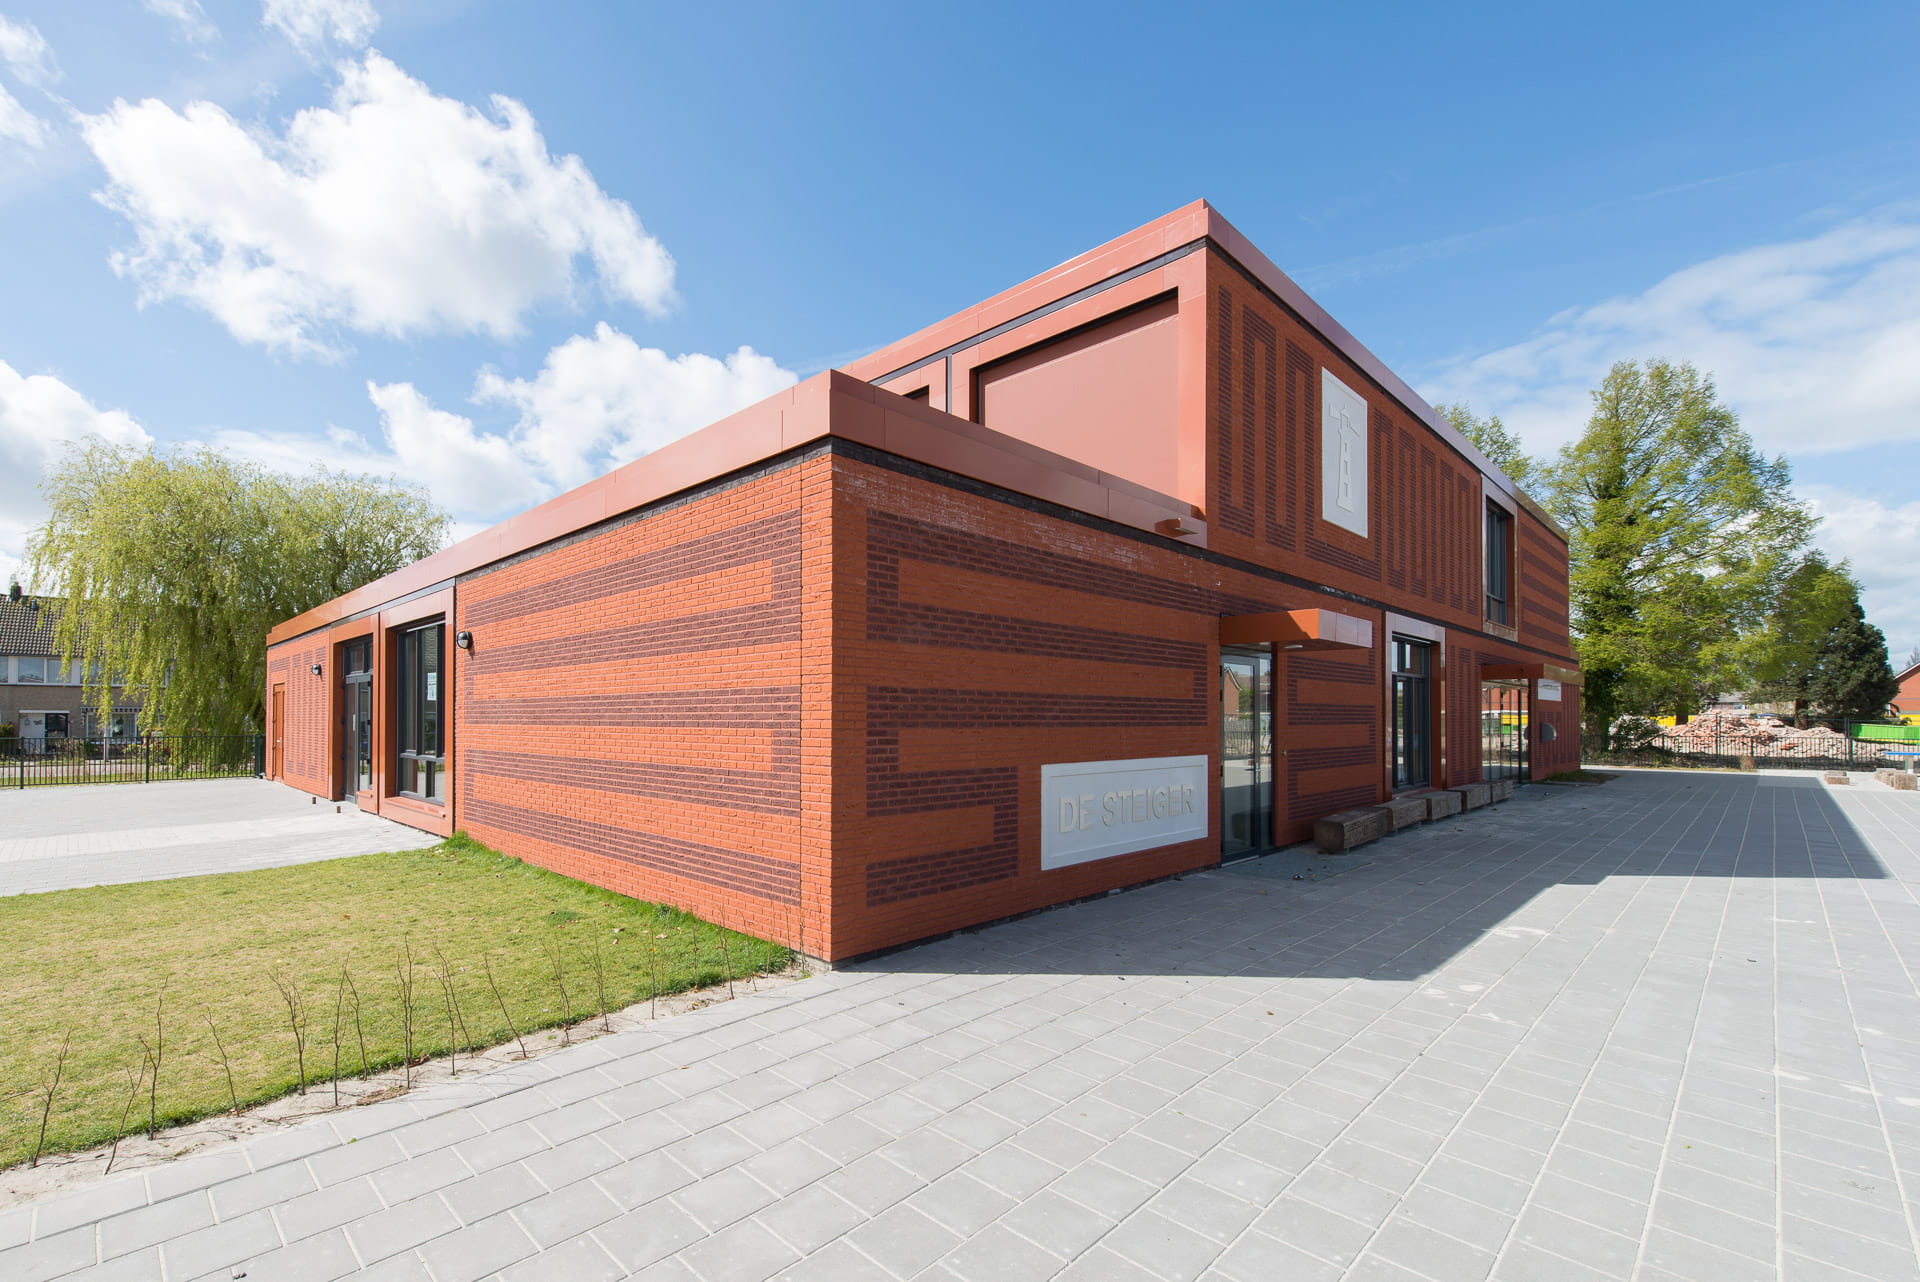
[843, 200, 1565, 514]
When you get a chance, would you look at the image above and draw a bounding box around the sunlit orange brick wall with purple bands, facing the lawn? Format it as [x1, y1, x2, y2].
[453, 459, 828, 950]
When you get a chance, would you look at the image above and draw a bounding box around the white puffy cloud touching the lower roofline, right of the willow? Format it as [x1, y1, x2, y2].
[474, 322, 795, 487]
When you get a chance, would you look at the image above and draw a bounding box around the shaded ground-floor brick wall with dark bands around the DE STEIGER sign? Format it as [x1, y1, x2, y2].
[831, 457, 1380, 956]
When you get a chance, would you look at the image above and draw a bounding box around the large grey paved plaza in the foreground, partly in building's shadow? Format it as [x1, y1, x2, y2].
[0, 772, 1920, 1282]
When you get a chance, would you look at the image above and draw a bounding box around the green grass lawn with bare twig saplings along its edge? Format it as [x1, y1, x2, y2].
[0, 837, 791, 1167]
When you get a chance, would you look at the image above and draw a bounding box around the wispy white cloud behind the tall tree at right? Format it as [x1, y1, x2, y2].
[1427, 209, 1920, 453]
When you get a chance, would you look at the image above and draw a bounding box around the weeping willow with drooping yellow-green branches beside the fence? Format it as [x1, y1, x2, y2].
[27, 439, 447, 735]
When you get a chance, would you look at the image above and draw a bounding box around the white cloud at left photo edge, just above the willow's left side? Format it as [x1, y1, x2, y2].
[0, 361, 152, 587]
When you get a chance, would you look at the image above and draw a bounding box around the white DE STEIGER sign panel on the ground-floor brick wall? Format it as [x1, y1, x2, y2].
[1041, 756, 1208, 867]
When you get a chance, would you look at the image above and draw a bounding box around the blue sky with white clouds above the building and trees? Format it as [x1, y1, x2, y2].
[0, 0, 1920, 666]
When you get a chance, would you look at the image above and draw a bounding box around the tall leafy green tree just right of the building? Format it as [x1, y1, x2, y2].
[1544, 361, 1814, 743]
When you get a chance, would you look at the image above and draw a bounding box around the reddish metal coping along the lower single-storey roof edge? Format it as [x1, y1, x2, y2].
[267, 370, 1206, 647]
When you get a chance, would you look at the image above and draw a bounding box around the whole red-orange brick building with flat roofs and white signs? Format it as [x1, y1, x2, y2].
[267, 203, 1578, 960]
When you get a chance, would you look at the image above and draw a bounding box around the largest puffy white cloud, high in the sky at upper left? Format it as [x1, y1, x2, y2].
[83, 54, 674, 355]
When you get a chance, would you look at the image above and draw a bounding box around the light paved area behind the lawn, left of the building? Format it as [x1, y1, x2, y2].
[0, 779, 440, 894]
